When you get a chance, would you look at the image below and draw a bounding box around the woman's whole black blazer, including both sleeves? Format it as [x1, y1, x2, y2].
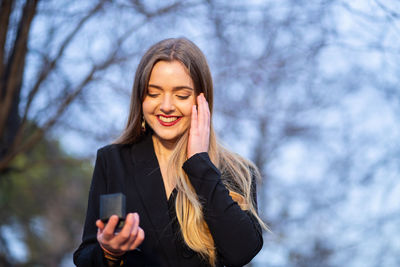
[74, 134, 263, 267]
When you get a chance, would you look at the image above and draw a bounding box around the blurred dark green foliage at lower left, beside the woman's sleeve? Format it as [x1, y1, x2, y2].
[0, 129, 93, 266]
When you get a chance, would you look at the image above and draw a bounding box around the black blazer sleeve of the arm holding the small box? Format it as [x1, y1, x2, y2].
[74, 150, 110, 267]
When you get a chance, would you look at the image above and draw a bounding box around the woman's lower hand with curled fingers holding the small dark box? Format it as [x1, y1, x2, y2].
[96, 213, 144, 256]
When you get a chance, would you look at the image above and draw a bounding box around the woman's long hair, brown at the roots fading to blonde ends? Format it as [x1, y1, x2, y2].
[115, 38, 267, 266]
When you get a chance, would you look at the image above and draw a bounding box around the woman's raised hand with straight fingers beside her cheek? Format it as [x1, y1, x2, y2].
[187, 93, 210, 158]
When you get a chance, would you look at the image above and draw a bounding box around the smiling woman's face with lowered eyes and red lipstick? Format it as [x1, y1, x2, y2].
[142, 61, 196, 142]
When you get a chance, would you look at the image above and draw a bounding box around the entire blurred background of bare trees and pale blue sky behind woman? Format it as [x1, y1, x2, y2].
[0, 0, 400, 267]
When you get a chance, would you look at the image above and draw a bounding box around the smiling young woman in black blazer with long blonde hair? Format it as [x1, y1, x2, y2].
[74, 38, 265, 267]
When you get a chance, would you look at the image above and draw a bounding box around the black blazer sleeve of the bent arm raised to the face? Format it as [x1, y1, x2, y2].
[183, 152, 263, 266]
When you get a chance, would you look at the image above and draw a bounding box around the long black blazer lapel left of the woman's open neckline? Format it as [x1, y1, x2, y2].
[131, 134, 177, 266]
